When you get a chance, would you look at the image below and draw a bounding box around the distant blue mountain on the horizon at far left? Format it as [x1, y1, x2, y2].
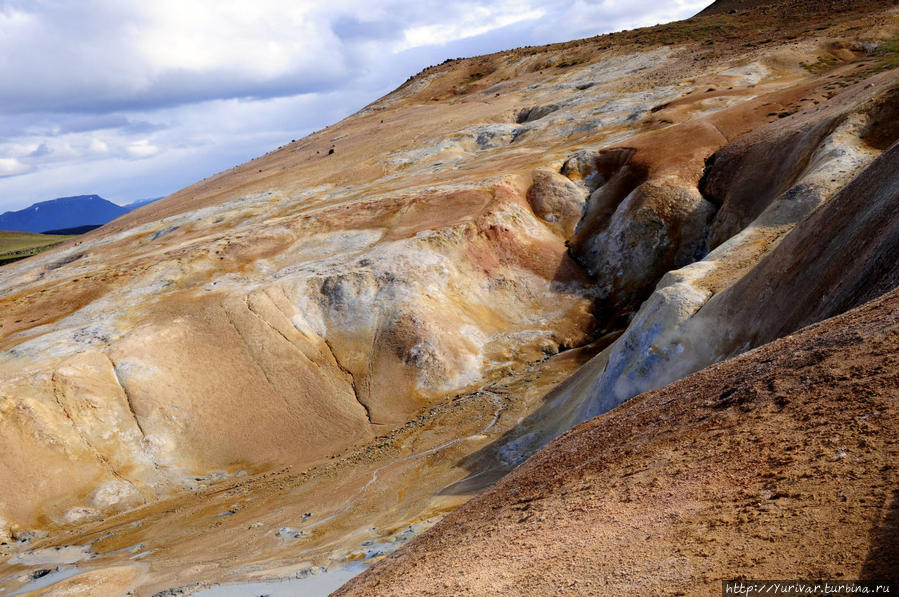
[0, 195, 159, 232]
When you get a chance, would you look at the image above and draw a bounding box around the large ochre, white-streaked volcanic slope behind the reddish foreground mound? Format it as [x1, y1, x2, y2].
[0, 0, 899, 595]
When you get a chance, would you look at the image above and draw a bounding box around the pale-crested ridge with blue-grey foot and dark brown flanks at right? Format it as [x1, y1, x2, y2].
[581, 78, 899, 419]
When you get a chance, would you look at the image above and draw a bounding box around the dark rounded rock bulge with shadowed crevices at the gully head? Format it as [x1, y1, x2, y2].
[561, 147, 718, 330]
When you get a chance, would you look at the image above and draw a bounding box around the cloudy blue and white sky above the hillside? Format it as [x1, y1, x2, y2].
[0, 0, 710, 212]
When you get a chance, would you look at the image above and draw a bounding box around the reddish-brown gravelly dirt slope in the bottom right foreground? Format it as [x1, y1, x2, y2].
[339, 291, 899, 595]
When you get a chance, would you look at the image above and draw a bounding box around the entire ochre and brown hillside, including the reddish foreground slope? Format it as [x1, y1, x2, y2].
[0, 0, 899, 596]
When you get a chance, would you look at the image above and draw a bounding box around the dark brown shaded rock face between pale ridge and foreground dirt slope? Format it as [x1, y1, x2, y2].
[699, 144, 899, 351]
